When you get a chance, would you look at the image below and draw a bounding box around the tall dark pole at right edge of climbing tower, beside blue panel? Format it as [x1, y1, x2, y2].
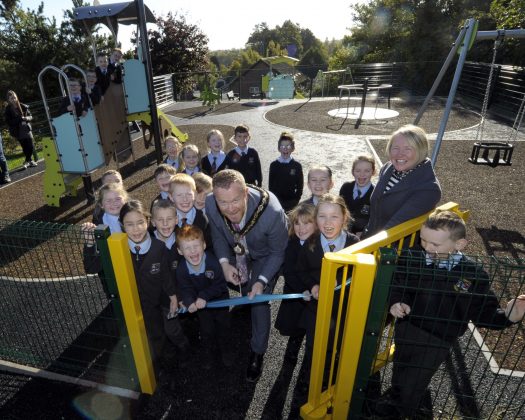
[135, 0, 162, 164]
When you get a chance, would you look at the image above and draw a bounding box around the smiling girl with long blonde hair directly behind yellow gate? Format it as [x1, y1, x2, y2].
[297, 193, 359, 357]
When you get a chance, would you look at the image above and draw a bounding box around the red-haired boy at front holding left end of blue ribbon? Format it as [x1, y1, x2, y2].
[177, 225, 235, 369]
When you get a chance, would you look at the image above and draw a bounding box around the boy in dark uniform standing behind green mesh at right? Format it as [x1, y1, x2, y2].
[376, 211, 525, 418]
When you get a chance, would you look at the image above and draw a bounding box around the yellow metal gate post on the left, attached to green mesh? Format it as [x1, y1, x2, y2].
[108, 233, 157, 394]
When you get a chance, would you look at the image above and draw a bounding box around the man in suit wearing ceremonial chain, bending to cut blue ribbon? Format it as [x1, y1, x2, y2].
[206, 169, 288, 382]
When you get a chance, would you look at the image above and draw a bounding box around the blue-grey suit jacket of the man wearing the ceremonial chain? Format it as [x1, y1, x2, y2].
[206, 187, 288, 284]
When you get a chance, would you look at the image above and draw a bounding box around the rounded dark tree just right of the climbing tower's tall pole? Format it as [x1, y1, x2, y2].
[148, 12, 208, 97]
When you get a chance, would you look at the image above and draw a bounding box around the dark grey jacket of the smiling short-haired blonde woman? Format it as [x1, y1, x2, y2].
[362, 158, 441, 238]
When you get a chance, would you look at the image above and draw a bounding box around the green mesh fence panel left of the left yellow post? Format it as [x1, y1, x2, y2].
[0, 220, 137, 389]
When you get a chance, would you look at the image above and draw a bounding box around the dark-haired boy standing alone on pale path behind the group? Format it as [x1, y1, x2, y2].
[268, 132, 304, 212]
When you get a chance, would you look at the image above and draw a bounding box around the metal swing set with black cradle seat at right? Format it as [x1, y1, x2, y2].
[414, 18, 525, 167]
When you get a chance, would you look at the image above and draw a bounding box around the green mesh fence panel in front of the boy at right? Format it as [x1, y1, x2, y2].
[349, 249, 525, 419]
